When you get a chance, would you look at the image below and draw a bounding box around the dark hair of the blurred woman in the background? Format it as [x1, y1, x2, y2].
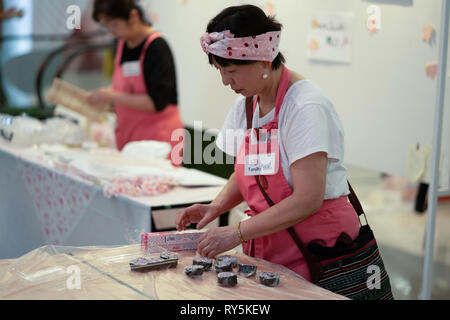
[92, 0, 152, 25]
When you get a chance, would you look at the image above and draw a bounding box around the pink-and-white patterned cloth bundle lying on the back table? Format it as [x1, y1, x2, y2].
[103, 176, 175, 198]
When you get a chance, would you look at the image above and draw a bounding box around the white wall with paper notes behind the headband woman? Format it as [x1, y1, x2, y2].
[147, 0, 448, 181]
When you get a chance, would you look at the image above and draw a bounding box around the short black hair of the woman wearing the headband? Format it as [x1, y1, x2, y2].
[206, 5, 286, 70]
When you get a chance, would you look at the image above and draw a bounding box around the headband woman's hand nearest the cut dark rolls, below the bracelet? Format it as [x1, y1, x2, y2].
[197, 226, 241, 258]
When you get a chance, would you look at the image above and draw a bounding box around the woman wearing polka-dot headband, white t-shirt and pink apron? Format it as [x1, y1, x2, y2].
[175, 5, 359, 280]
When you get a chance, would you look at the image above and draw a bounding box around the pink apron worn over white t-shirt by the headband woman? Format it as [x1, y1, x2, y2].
[235, 67, 359, 280]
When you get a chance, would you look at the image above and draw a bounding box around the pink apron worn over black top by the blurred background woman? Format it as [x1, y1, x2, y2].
[112, 32, 184, 163]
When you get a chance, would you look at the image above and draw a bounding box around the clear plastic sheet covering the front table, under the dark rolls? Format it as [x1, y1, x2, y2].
[0, 244, 345, 300]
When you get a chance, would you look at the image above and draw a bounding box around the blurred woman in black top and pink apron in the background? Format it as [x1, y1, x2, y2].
[89, 0, 184, 165]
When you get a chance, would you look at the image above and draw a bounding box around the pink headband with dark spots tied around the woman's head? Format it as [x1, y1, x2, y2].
[200, 30, 281, 62]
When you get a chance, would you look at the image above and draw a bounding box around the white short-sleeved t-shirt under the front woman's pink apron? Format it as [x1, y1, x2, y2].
[216, 80, 349, 199]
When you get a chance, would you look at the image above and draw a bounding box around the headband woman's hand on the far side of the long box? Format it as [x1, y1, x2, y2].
[175, 203, 219, 231]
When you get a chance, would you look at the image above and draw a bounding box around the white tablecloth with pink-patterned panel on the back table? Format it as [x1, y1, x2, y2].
[0, 143, 224, 259]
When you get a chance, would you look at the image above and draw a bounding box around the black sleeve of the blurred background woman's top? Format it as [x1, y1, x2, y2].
[144, 37, 178, 111]
